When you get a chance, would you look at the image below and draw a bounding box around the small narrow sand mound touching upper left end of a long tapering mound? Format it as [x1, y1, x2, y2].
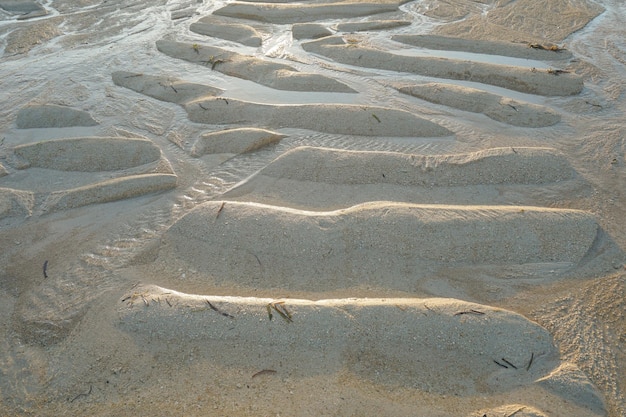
[112, 71, 223, 104]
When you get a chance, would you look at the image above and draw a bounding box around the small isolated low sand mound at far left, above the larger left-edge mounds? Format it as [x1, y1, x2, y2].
[16, 104, 98, 129]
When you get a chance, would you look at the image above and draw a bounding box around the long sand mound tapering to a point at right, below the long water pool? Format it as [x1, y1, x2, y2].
[185, 98, 452, 137]
